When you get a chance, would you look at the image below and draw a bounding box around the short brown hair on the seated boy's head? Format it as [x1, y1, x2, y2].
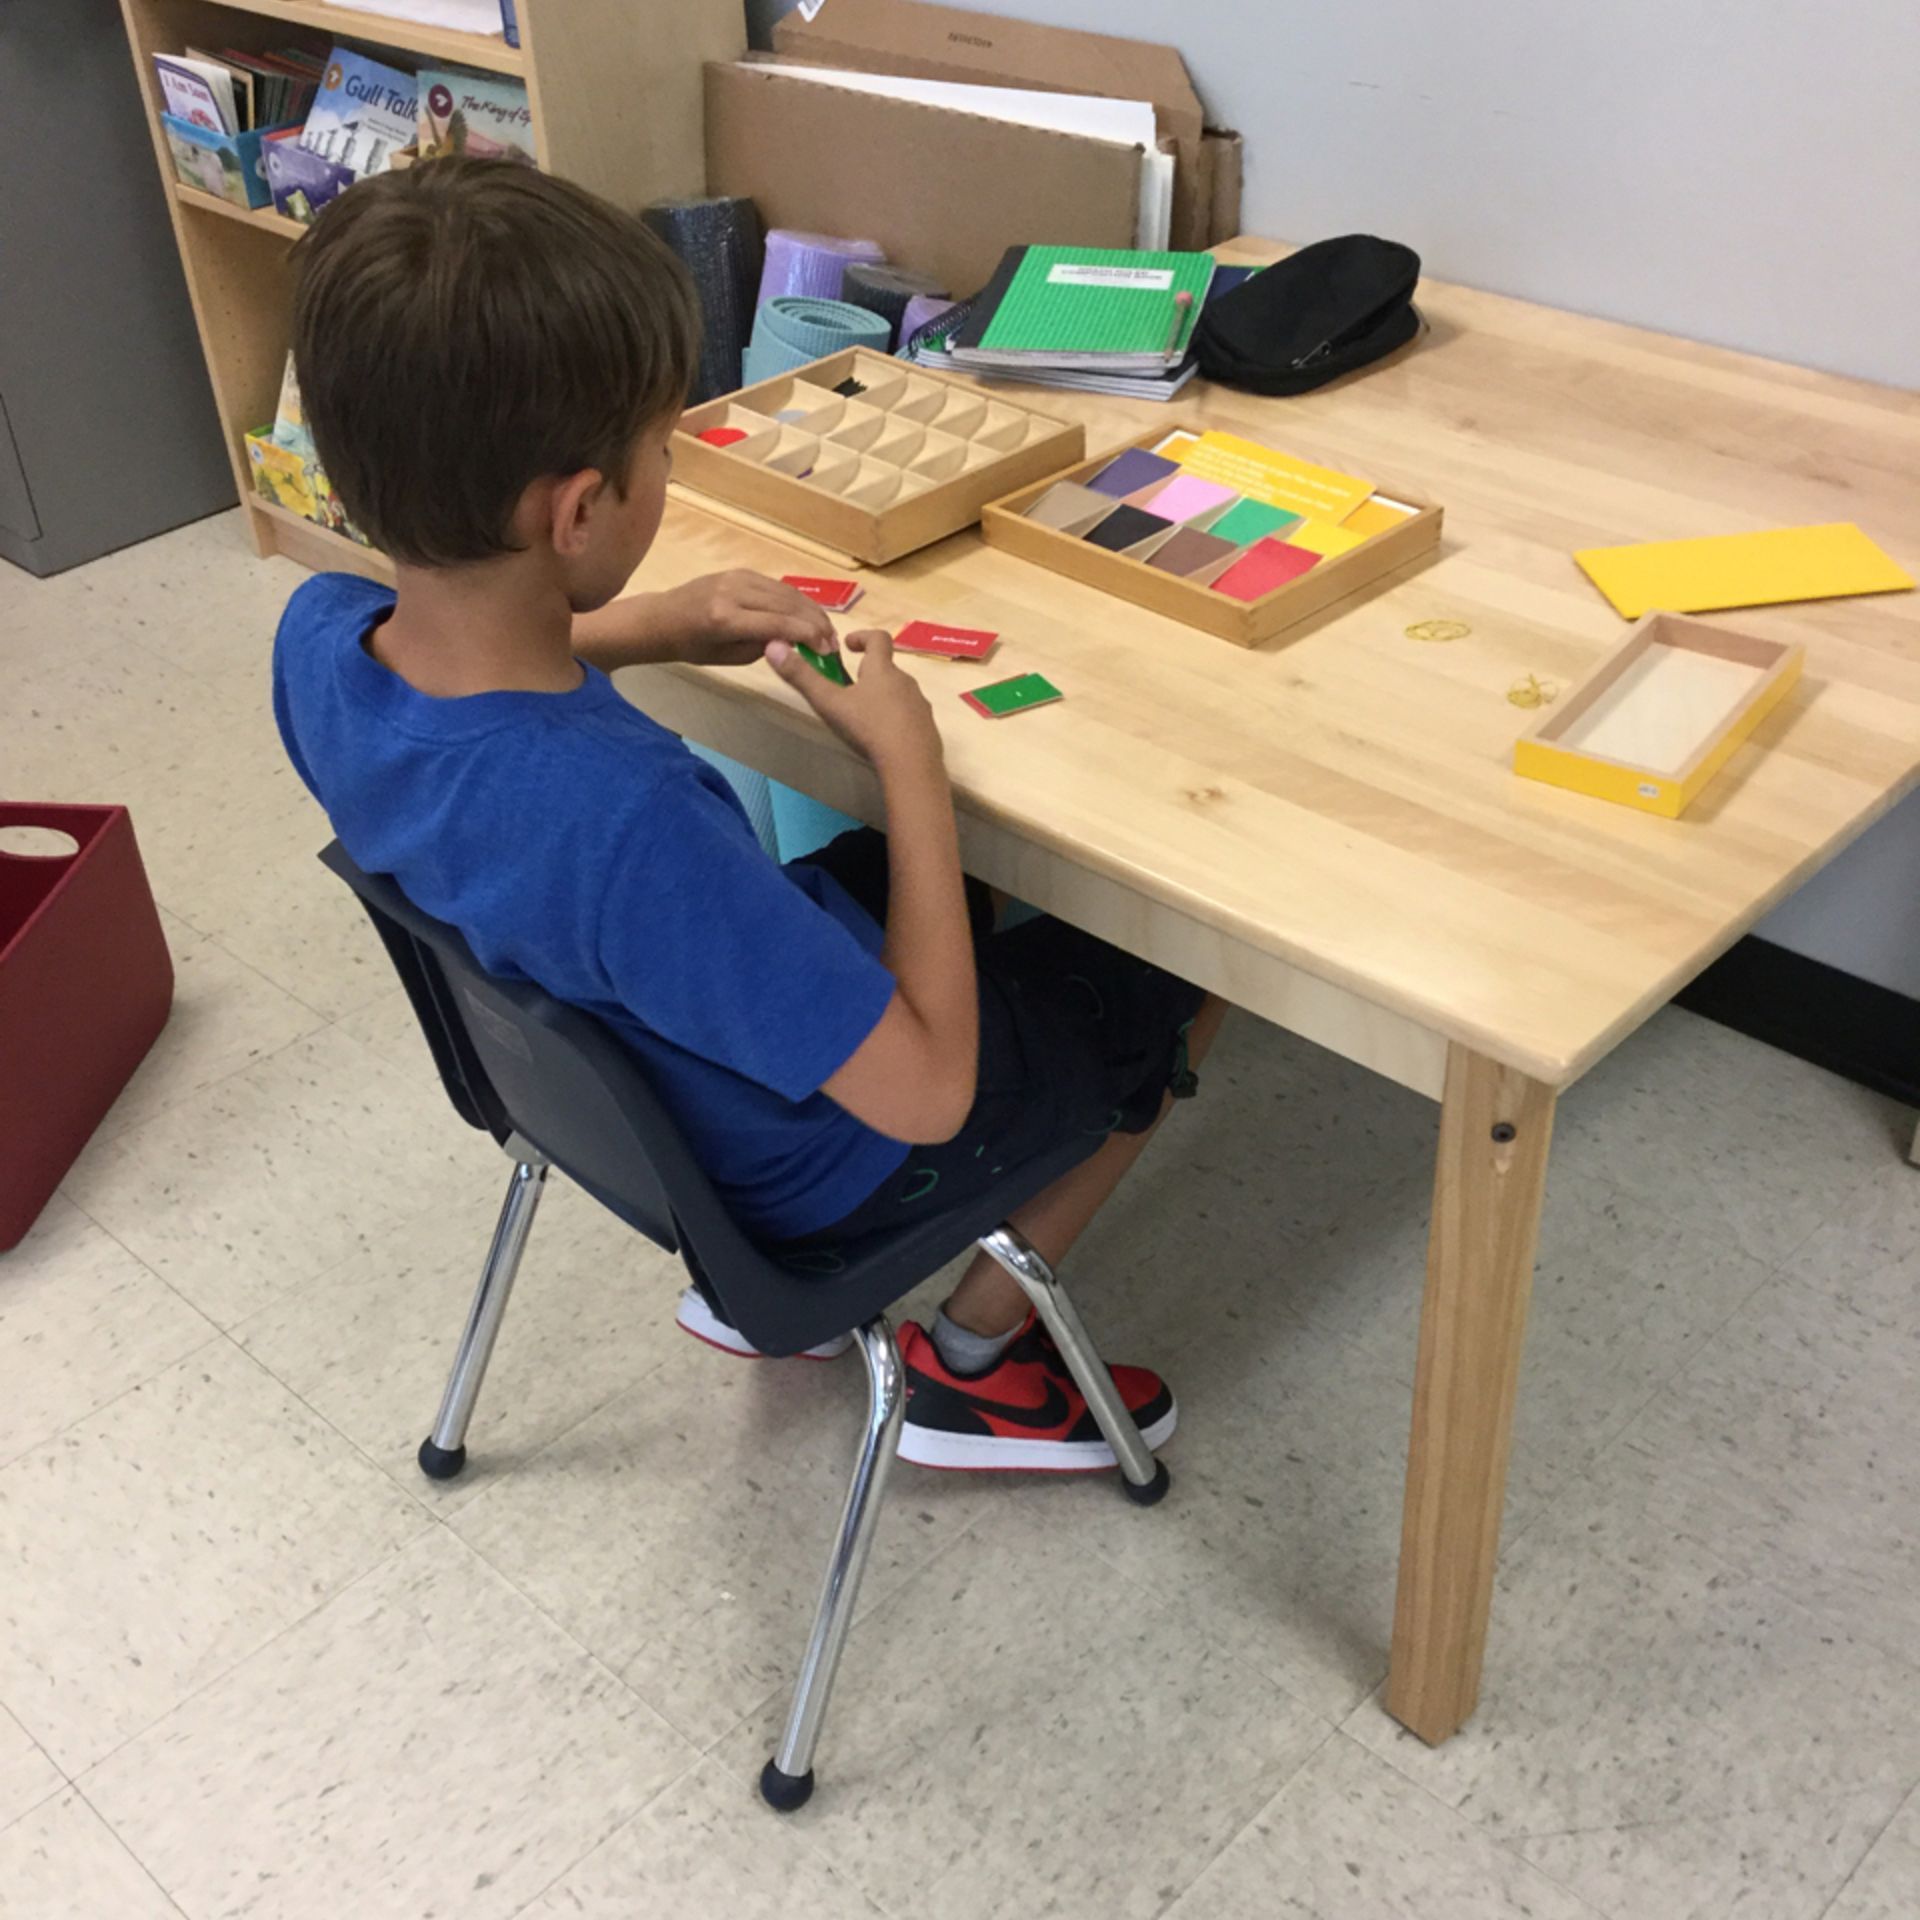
[294, 159, 699, 566]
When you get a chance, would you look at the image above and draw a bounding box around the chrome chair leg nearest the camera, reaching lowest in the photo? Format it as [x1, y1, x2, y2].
[760, 1313, 906, 1812]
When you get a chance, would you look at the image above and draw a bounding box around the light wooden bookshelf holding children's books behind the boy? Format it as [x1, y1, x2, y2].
[121, 0, 747, 578]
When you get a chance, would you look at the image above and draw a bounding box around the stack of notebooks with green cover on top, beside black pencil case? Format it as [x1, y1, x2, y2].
[902, 246, 1256, 401]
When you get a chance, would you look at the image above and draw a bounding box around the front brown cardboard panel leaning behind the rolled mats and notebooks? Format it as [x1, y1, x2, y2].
[707, 63, 1140, 296]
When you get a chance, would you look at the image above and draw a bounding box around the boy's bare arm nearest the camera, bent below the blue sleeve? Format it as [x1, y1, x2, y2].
[768, 632, 979, 1142]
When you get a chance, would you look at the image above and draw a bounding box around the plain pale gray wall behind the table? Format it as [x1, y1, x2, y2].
[749, 0, 1920, 995]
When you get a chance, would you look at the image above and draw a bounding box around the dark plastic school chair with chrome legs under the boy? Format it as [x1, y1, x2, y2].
[321, 841, 1167, 1812]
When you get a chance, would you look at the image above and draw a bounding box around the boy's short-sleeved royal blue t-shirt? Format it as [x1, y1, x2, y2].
[273, 574, 906, 1238]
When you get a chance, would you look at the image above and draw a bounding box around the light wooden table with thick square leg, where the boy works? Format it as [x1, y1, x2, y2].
[624, 242, 1920, 1741]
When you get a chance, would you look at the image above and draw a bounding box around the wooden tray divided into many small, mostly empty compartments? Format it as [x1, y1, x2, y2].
[674, 348, 1087, 566]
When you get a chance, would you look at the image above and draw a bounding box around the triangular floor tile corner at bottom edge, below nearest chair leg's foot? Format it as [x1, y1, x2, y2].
[524, 1761, 883, 1920]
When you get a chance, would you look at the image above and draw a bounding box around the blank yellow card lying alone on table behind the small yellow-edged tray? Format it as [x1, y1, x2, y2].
[1574, 520, 1912, 620]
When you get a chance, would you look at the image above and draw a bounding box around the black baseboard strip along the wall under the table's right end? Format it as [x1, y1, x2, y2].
[1678, 935, 1920, 1106]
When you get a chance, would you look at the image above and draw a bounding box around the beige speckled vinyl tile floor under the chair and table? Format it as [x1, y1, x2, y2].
[0, 515, 1920, 1920]
